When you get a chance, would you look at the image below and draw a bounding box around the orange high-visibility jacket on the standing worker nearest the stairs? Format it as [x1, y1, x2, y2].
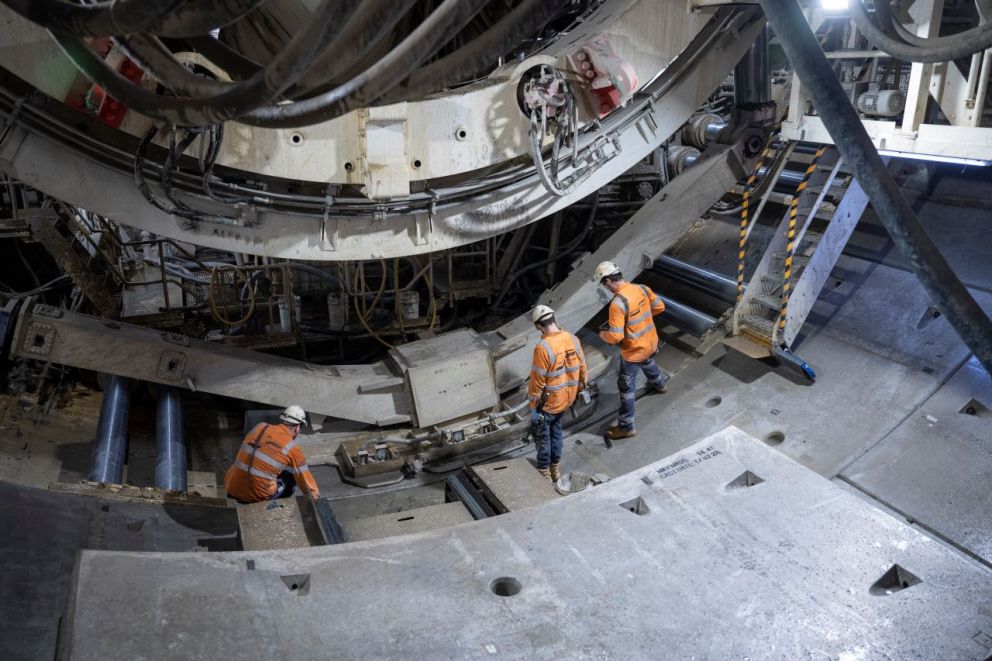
[601, 282, 665, 363]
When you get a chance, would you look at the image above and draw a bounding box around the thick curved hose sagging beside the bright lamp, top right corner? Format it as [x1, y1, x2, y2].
[851, 0, 992, 63]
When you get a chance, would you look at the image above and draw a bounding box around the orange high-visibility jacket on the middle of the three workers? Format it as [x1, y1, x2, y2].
[527, 330, 588, 414]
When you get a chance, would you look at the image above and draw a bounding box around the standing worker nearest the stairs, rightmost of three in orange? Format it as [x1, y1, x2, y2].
[593, 262, 668, 440]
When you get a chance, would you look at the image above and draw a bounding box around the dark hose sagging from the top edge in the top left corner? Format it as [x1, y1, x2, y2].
[2, 0, 188, 37]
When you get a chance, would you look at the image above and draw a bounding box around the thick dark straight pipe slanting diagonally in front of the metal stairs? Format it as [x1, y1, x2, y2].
[760, 0, 992, 374]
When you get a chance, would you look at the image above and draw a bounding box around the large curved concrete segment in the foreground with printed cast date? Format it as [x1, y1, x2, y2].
[61, 427, 992, 659]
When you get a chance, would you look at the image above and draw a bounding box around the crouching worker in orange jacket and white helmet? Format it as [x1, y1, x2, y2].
[224, 404, 320, 503]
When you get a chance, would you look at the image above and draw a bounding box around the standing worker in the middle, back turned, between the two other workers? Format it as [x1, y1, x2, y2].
[527, 305, 588, 481]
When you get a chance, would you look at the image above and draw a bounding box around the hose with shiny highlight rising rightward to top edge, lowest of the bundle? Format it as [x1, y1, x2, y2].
[240, 0, 488, 128]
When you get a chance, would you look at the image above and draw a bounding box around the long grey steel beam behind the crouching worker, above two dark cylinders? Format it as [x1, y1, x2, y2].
[11, 305, 410, 425]
